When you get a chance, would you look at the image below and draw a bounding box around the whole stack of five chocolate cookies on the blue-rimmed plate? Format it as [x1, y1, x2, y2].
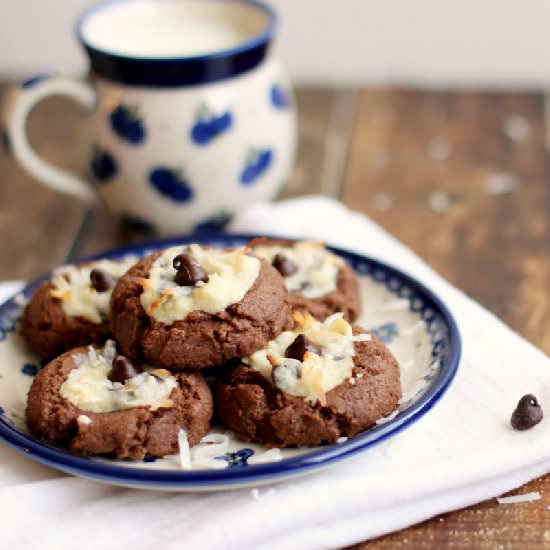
[23, 239, 401, 459]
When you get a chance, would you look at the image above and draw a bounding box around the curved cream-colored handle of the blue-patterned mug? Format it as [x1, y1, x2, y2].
[5, 76, 97, 203]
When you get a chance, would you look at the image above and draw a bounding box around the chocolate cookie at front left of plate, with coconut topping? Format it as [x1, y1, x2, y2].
[26, 340, 212, 459]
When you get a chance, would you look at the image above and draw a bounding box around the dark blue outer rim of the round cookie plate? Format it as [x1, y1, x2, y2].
[0, 231, 461, 489]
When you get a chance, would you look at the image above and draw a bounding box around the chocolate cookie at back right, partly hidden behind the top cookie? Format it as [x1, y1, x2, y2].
[249, 239, 361, 321]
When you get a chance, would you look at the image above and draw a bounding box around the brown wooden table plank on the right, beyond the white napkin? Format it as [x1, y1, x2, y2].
[343, 89, 550, 550]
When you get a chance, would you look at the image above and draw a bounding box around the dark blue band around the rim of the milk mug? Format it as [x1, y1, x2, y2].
[75, 0, 277, 87]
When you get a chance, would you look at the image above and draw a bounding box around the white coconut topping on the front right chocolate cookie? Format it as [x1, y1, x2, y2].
[244, 313, 370, 405]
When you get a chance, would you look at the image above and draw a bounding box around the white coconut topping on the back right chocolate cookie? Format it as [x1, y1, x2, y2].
[252, 241, 345, 298]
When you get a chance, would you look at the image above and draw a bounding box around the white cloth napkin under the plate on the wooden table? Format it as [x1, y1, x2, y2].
[0, 197, 550, 550]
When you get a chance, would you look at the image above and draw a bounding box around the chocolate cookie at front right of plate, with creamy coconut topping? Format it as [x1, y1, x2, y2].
[216, 316, 401, 447]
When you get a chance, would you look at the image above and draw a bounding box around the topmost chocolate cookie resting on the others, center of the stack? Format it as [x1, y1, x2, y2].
[111, 245, 292, 369]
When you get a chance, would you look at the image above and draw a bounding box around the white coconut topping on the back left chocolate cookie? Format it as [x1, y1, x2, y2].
[50, 256, 137, 324]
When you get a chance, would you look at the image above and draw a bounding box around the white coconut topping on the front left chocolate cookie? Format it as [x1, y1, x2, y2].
[60, 340, 177, 413]
